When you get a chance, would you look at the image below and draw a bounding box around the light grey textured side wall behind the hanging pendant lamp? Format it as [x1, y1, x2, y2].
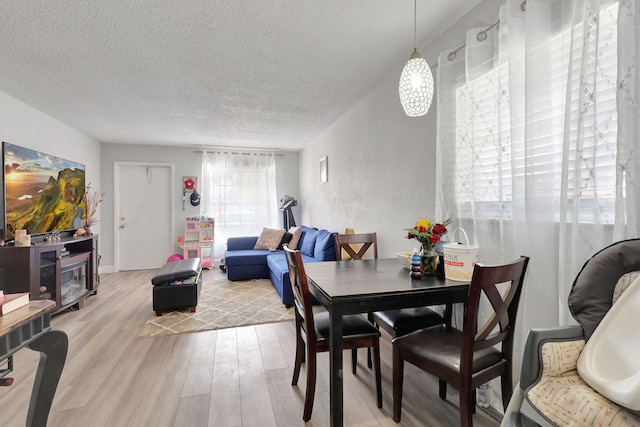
[300, 0, 503, 257]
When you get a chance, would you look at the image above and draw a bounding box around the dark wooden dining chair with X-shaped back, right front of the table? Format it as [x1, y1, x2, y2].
[393, 256, 529, 427]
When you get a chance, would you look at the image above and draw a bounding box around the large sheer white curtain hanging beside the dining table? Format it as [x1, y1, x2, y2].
[436, 0, 640, 392]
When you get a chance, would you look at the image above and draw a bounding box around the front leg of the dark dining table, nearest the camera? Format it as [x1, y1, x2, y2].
[329, 310, 343, 427]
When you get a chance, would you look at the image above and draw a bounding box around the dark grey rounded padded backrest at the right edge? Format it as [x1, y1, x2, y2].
[568, 239, 640, 340]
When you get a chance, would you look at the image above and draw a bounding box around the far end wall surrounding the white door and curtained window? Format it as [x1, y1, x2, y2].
[100, 144, 300, 271]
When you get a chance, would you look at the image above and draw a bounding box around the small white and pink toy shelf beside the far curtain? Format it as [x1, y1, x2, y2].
[178, 217, 215, 268]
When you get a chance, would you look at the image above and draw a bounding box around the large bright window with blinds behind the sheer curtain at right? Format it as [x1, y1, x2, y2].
[455, 2, 624, 224]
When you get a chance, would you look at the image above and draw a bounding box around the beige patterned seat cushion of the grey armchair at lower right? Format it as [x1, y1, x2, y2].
[526, 340, 640, 427]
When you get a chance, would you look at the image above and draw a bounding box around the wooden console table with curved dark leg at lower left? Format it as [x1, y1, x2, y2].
[0, 300, 68, 427]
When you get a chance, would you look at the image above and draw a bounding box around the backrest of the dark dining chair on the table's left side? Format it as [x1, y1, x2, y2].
[283, 245, 316, 343]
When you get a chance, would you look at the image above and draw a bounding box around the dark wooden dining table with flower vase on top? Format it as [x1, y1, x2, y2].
[305, 258, 469, 427]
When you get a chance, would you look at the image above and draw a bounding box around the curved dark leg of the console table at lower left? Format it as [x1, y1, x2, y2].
[27, 330, 69, 427]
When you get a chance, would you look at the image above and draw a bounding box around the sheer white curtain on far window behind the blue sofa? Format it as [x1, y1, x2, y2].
[200, 151, 278, 259]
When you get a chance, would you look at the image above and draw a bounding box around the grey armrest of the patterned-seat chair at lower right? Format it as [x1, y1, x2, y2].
[520, 325, 584, 390]
